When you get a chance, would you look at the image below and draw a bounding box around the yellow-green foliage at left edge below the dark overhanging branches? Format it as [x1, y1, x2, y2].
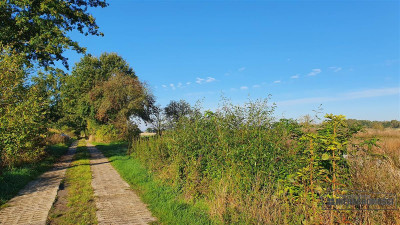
[0, 47, 49, 169]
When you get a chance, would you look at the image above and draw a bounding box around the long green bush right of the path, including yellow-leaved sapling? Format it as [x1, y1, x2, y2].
[130, 100, 360, 224]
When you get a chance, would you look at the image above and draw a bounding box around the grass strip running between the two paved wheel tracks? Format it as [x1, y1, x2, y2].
[47, 140, 97, 224]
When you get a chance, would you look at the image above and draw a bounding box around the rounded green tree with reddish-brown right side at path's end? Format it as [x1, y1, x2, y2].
[61, 53, 154, 141]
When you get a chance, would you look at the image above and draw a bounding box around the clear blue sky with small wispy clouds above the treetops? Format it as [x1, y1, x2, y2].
[63, 0, 400, 120]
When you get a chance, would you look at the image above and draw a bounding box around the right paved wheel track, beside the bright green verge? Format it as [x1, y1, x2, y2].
[87, 143, 156, 224]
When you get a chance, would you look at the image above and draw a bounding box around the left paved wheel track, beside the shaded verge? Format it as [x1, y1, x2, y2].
[0, 142, 77, 225]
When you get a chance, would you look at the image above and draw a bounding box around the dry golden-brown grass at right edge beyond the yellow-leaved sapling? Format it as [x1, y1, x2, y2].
[349, 129, 400, 224]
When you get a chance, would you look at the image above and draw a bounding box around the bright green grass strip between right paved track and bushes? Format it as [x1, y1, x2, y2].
[96, 143, 214, 224]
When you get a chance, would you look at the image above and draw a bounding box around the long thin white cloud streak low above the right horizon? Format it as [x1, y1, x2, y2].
[277, 87, 400, 106]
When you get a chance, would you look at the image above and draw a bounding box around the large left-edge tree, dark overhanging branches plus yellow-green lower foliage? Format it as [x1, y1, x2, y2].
[0, 0, 107, 169]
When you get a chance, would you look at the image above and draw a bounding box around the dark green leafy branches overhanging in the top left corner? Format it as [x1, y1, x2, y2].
[0, 0, 107, 68]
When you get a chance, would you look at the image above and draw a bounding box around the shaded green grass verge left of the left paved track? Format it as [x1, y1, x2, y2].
[0, 144, 72, 207]
